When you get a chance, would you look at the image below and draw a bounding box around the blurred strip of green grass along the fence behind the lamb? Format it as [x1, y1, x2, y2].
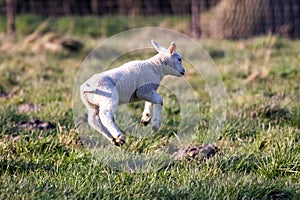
[0, 15, 190, 38]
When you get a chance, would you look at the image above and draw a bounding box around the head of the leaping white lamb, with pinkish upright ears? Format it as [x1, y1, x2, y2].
[151, 40, 185, 77]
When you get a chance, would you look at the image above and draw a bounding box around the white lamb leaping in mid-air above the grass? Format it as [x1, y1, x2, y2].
[80, 40, 185, 146]
